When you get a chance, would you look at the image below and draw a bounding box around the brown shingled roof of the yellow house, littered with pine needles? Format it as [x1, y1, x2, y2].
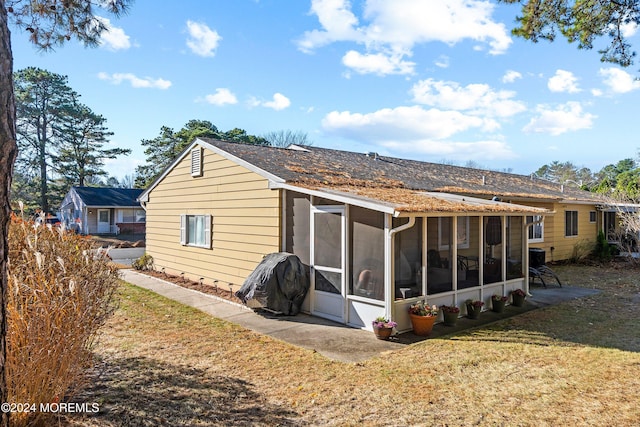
[192, 138, 600, 211]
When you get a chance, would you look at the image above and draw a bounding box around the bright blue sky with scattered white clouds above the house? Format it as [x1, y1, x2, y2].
[11, 0, 640, 179]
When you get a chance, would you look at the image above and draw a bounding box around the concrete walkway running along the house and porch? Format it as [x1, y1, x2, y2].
[120, 269, 598, 362]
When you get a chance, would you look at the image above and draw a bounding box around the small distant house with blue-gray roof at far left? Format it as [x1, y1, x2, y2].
[60, 187, 146, 234]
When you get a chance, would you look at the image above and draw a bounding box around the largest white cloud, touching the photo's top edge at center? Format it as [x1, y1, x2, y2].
[298, 0, 512, 74]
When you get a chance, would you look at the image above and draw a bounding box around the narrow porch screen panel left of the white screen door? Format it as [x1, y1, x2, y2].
[285, 191, 311, 265]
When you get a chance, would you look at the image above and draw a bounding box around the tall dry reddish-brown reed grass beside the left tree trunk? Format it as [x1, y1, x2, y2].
[6, 217, 119, 426]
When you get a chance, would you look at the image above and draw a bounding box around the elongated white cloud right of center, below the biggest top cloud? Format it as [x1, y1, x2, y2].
[410, 79, 526, 117]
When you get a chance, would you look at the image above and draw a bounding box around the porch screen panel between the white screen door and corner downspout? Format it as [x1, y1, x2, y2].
[349, 206, 384, 300]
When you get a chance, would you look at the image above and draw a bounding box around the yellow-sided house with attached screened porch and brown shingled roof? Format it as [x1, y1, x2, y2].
[140, 138, 620, 331]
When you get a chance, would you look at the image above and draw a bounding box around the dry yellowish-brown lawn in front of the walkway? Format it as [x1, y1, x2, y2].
[62, 263, 640, 426]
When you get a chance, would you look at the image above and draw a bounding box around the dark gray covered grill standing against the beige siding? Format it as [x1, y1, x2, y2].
[236, 252, 310, 316]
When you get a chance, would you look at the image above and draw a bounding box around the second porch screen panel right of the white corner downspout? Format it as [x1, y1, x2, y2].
[426, 217, 455, 295]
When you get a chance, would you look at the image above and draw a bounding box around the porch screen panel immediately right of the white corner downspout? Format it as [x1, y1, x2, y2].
[393, 218, 422, 298]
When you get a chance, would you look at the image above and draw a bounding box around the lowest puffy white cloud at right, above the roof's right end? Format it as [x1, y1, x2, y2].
[522, 102, 597, 136]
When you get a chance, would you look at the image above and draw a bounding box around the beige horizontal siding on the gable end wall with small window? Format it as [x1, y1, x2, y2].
[147, 149, 280, 291]
